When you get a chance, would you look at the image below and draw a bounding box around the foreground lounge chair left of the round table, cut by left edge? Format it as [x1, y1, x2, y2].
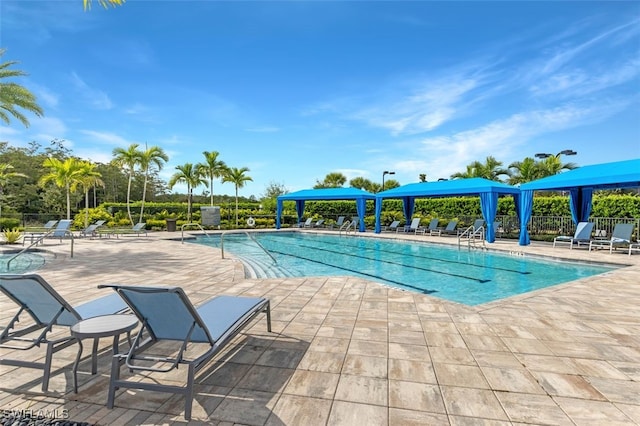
[0, 274, 127, 392]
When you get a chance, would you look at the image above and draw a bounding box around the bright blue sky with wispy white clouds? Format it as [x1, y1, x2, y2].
[0, 0, 640, 197]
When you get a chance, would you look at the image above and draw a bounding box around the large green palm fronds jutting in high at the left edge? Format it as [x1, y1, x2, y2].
[0, 49, 44, 127]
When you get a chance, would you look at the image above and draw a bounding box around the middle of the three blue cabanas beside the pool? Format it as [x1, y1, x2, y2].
[376, 178, 520, 243]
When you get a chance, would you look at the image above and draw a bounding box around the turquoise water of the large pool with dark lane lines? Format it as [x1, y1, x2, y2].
[189, 232, 615, 305]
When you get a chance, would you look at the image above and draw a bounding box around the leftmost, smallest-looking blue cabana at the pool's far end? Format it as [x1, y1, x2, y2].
[276, 188, 376, 232]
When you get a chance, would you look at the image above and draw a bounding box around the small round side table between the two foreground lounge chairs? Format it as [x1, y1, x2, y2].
[71, 314, 138, 393]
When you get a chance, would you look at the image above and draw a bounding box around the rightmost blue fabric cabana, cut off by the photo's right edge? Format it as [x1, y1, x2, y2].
[520, 159, 640, 245]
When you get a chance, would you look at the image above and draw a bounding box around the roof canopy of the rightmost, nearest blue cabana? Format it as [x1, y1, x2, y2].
[520, 159, 640, 191]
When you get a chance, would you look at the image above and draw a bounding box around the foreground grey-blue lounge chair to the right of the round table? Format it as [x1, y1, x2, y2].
[99, 285, 271, 420]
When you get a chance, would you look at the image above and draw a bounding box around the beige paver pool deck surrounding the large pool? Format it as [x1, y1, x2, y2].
[0, 231, 640, 425]
